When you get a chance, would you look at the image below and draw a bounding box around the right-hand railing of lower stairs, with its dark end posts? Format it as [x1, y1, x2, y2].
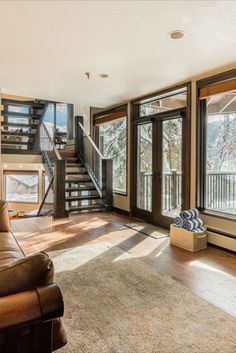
[75, 116, 113, 209]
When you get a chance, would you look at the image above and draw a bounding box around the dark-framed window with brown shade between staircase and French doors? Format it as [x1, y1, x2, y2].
[93, 105, 128, 195]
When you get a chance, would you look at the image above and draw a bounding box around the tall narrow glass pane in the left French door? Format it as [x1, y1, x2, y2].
[137, 124, 153, 211]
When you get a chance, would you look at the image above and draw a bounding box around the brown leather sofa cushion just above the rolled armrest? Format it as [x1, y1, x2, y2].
[0, 252, 54, 297]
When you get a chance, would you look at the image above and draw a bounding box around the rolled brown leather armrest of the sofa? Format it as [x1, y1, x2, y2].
[0, 284, 64, 331]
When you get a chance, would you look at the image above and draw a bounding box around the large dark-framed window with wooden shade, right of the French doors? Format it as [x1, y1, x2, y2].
[197, 70, 236, 219]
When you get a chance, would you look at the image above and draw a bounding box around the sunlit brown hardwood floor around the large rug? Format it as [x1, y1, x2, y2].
[12, 212, 236, 316]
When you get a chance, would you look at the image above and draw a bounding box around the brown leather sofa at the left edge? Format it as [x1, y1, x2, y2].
[0, 201, 66, 353]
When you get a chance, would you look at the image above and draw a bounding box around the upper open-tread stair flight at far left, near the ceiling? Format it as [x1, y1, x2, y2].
[1, 99, 46, 153]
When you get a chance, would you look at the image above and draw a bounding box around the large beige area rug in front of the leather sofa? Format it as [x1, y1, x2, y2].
[50, 242, 236, 353]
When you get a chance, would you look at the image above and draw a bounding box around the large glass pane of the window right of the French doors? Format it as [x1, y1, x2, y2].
[205, 91, 236, 215]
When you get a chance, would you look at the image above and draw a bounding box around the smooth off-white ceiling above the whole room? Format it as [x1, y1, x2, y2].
[0, 0, 236, 107]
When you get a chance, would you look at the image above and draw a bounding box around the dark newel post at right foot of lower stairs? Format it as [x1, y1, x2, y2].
[102, 159, 113, 211]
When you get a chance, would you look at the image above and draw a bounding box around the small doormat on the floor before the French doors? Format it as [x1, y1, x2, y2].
[125, 222, 170, 239]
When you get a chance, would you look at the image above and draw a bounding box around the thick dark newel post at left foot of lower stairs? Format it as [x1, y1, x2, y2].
[53, 159, 66, 218]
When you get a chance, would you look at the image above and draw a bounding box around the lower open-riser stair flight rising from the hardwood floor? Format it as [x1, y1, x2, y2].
[60, 150, 105, 214]
